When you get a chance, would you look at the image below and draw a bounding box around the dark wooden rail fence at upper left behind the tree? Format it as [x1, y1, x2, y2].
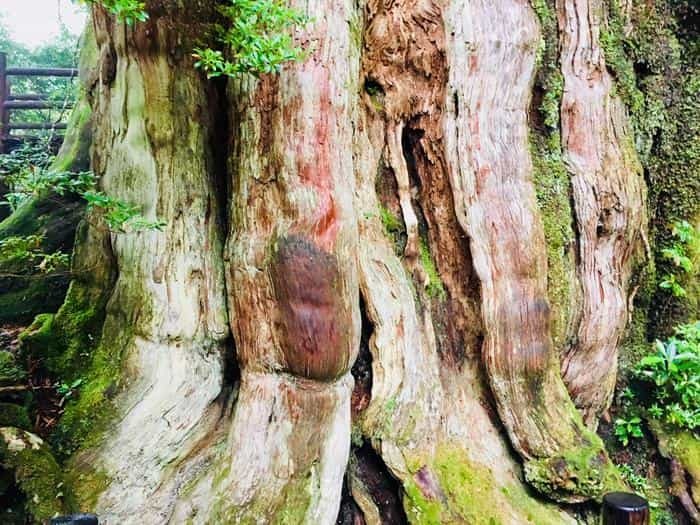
[0, 53, 78, 153]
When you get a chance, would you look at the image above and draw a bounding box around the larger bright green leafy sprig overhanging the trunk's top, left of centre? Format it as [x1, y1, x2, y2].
[194, 0, 308, 78]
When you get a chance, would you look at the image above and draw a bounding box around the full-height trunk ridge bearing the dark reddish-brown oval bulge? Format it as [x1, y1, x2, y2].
[205, 0, 360, 524]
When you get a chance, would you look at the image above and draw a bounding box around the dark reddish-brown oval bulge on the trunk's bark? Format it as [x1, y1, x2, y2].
[271, 236, 352, 380]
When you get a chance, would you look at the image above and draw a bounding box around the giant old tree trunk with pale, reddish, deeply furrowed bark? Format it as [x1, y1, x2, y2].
[15, 0, 700, 524]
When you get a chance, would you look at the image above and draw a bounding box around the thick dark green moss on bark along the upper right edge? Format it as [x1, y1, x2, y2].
[601, 0, 700, 332]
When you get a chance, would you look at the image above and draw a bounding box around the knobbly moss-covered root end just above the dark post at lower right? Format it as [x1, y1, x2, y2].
[525, 430, 627, 503]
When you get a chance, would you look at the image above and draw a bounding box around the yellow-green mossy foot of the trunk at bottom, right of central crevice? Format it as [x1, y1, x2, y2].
[404, 445, 573, 525]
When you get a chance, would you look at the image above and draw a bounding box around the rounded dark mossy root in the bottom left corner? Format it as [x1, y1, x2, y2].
[0, 427, 72, 521]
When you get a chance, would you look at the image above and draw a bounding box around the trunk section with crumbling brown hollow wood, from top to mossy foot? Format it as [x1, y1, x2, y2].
[355, 1, 600, 512]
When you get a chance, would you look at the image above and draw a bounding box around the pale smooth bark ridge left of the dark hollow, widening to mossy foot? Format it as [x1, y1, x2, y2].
[352, 100, 569, 524]
